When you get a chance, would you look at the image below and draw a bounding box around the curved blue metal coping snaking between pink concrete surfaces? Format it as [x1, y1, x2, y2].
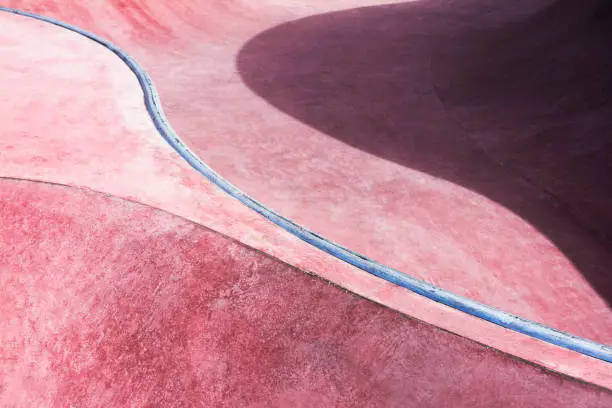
[0, 7, 612, 363]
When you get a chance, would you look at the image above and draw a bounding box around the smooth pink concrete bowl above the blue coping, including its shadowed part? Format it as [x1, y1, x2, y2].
[7, 0, 612, 343]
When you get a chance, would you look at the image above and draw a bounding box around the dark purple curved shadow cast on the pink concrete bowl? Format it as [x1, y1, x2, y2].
[237, 0, 612, 304]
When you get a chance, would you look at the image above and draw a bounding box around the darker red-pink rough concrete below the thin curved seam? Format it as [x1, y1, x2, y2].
[0, 180, 612, 408]
